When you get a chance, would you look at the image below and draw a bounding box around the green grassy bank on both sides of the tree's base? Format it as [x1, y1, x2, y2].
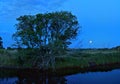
[0, 49, 120, 69]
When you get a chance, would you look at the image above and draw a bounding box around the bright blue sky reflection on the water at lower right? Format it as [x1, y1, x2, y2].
[65, 69, 120, 84]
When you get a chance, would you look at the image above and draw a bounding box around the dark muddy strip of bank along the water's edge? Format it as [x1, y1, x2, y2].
[0, 63, 120, 77]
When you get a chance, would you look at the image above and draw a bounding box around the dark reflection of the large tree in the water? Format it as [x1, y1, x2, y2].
[15, 77, 65, 84]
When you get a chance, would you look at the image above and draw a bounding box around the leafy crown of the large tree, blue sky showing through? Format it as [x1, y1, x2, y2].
[13, 11, 79, 50]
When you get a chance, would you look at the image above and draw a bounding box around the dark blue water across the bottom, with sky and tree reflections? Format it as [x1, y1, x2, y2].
[0, 69, 120, 84]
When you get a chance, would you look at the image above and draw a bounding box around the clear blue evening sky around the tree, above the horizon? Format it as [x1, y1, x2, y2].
[0, 0, 120, 48]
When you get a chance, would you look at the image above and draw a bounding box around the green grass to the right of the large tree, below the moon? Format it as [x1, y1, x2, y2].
[56, 50, 120, 68]
